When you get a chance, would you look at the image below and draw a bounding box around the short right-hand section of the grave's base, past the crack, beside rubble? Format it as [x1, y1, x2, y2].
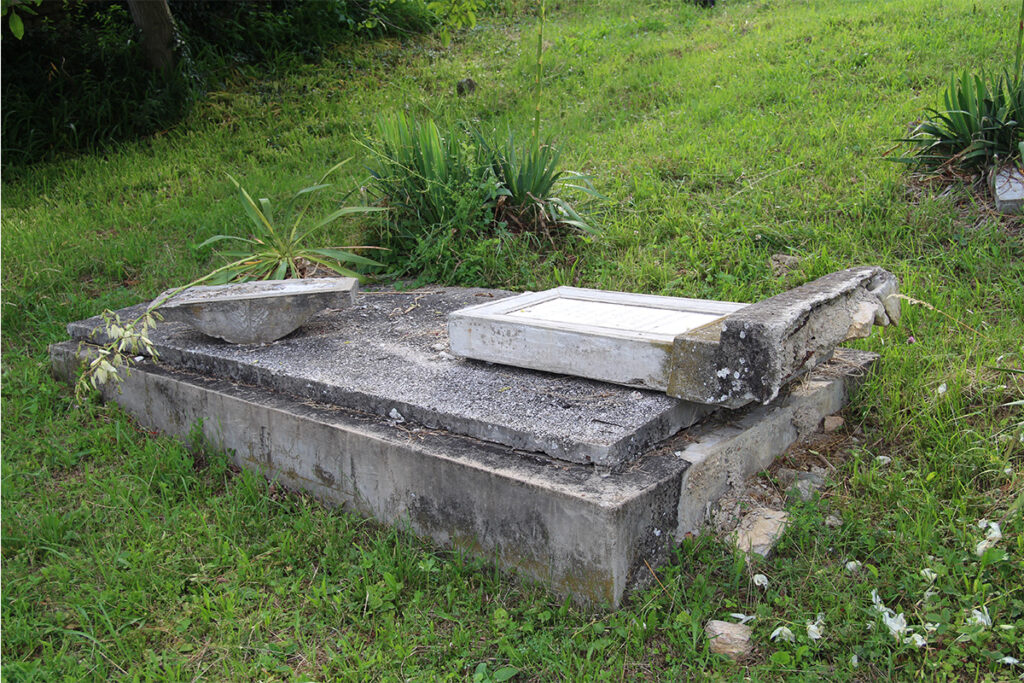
[676, 348, 879, 541]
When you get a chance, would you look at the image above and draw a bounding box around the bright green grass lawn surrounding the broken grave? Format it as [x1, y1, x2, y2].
[0, 0, 1024, 681]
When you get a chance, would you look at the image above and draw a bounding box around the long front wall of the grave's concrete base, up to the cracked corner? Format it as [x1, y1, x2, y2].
[50, 342, 688, 606]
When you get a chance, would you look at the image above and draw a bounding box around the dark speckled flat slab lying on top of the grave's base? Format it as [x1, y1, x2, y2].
[69, 288, 713, 469]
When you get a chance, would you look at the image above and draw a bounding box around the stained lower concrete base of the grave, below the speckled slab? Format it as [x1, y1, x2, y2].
[50, 342, 874, 606]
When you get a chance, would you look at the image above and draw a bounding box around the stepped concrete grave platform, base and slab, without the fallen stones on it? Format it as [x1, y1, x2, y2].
[50, 289, 874, 605]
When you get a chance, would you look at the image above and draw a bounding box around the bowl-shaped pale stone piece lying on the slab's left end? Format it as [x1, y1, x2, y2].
[154, 278, 359, 344]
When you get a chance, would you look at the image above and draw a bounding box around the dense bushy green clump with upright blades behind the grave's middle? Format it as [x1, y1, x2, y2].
[365, 114, 595, 284]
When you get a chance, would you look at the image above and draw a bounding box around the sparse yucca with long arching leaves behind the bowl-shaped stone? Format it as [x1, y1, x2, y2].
[200, 159, 383, 284]
